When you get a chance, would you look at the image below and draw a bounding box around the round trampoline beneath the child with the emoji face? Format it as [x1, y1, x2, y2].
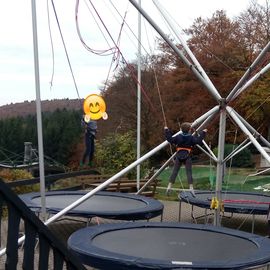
[20, 191, 164, 220]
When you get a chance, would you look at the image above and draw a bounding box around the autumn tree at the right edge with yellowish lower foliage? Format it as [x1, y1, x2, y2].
[233, 0, 270, 139]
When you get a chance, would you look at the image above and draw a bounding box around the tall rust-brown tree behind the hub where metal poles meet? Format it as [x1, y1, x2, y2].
[153, 11, 246, 143]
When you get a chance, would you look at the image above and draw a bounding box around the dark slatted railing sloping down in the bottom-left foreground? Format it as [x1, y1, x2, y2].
[0, 179, 86, 270]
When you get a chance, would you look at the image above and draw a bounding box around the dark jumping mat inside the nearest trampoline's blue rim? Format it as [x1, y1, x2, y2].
[91, 228, 258, 262]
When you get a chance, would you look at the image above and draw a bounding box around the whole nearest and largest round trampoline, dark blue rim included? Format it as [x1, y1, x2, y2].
[68, 222, 270, 270]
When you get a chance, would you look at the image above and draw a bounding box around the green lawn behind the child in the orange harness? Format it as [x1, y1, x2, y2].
[157, 165, 270, 200]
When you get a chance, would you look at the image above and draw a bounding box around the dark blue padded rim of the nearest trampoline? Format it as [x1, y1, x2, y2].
[68, 222, 270, 270]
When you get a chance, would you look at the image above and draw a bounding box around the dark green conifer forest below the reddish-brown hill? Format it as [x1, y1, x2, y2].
[0, 109, 82, 165]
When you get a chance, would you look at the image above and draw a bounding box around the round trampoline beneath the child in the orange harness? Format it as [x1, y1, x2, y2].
[179, 191, 270, 215]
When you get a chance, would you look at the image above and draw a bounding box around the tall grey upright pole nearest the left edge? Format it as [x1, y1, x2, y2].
[32, 0, 46, 221]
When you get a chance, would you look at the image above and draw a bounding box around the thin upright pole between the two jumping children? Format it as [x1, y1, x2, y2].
[137, 0, 141, 191]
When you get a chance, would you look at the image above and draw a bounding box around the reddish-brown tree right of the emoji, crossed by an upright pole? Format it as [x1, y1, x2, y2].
[103, 55, 170, 154]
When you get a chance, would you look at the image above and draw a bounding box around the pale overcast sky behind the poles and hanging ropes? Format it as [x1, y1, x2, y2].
[0, 0, 264, 106]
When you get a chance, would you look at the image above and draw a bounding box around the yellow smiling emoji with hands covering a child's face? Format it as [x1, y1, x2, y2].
[83, 94, 108, 122]
